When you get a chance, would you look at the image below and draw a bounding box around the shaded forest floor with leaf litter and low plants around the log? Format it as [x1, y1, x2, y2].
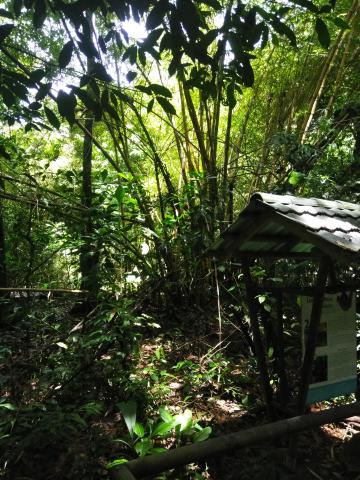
[0, 301, 360, 480]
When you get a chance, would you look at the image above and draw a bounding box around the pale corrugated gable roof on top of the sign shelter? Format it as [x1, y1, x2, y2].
[211, 192, 360, 261]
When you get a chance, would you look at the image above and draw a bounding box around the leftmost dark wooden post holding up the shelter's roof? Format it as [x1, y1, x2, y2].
[242, 259, 275, 420]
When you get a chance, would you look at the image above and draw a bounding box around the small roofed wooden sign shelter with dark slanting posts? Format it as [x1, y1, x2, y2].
[211, 193, 360, 418]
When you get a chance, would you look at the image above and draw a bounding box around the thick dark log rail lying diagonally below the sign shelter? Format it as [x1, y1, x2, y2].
[110, 402, 360, 480]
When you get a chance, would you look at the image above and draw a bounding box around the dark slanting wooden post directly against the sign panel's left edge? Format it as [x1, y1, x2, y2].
[297, 257, 330, 415]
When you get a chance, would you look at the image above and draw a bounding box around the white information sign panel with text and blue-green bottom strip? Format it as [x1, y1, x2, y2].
[301, 294, 357, 403]
